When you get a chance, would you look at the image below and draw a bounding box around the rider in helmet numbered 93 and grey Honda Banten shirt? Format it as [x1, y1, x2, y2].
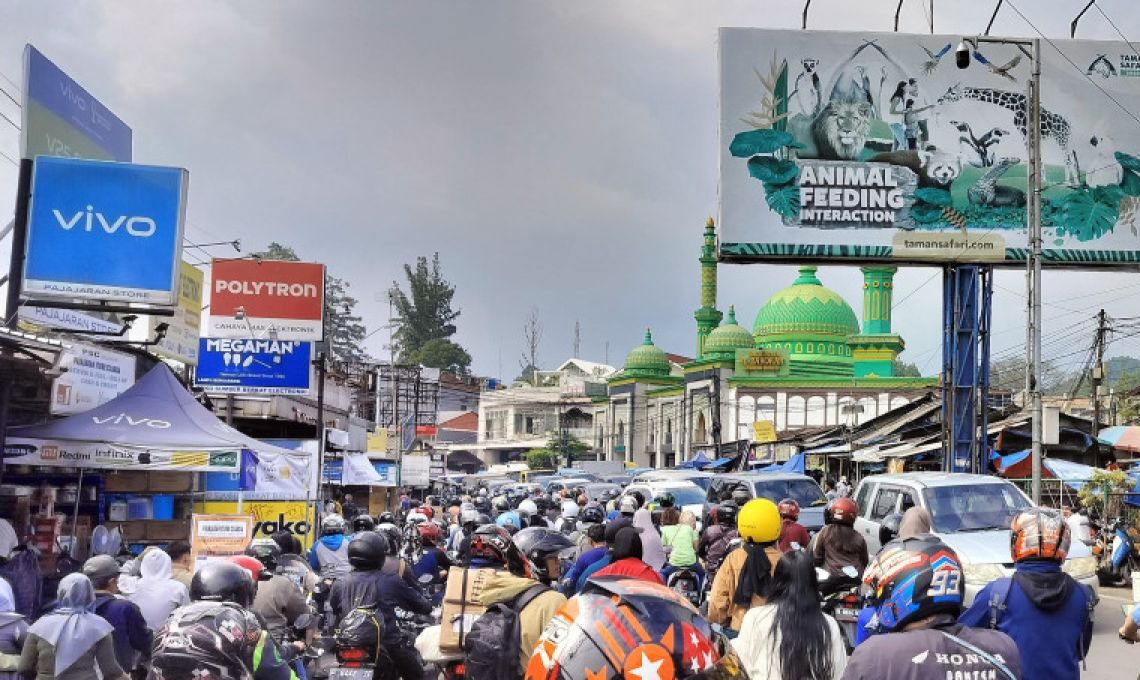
[844, 534, 1026, 680]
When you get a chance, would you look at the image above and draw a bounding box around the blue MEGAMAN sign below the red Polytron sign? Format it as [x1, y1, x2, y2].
[194, 338, 312, 395]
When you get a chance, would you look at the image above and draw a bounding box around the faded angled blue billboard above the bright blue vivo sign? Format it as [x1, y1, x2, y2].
[21, 44, 132, 163]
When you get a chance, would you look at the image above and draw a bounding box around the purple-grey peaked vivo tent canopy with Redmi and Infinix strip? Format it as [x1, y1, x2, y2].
[5, 364, 311, 472]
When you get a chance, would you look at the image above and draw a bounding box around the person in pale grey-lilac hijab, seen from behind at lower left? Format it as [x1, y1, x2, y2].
[19, 574, 128, 680]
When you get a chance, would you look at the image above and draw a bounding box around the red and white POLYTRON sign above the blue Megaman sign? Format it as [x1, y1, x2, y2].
[210, 260, 325, 341]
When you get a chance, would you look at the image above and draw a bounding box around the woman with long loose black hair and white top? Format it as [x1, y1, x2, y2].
[732, 550, 847, 680]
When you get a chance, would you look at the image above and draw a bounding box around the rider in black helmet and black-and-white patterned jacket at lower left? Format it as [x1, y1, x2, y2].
[147, 561, 296, 680]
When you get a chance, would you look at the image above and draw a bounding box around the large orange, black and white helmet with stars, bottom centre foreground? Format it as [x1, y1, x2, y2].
[524, 578, 748, 680]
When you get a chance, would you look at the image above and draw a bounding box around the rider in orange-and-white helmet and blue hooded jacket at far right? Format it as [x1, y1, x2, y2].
[958, 508, 1097, 679]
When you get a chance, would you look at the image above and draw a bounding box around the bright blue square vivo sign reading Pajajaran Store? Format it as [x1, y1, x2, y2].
[22, 156, 189, 305]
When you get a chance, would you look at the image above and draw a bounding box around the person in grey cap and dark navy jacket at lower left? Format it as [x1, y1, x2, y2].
[83, 554, 154, 673]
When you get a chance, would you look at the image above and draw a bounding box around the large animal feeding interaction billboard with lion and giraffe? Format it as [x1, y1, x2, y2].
[718, 29, 1140, 268]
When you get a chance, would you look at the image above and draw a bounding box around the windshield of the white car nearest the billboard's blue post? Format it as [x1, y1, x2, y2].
[922, 484, 1032, 534]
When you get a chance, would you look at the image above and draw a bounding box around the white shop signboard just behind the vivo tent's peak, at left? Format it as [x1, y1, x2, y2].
[51, 342, 135, 415]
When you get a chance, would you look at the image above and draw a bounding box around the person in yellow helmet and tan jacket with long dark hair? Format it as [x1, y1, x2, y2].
[708, 499, 782, 637]
